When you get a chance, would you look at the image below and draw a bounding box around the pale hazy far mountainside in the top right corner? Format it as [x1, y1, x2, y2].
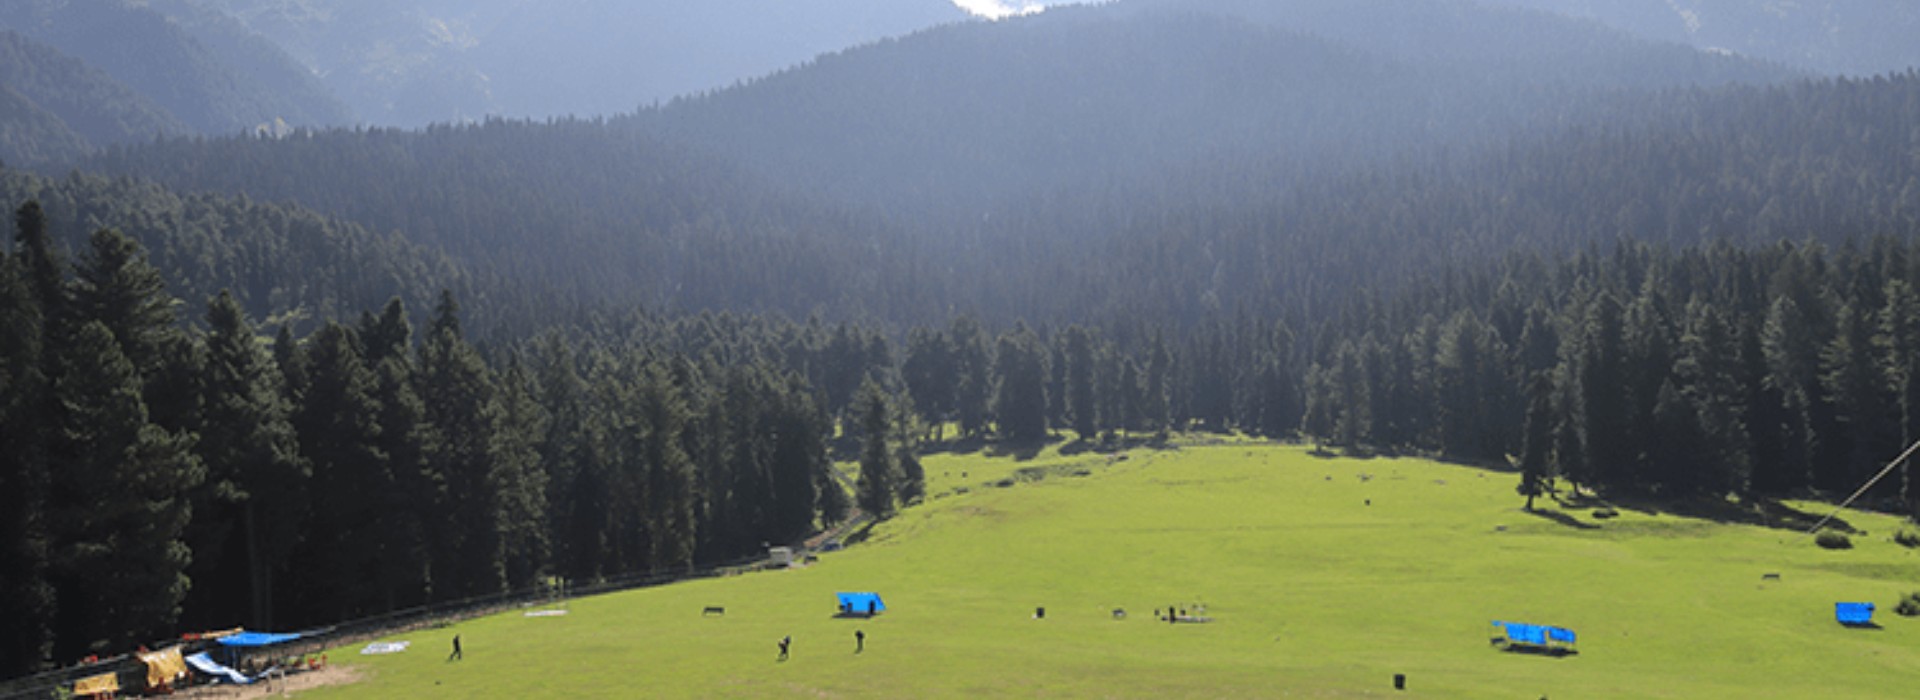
[1484, 0, 1920, 75]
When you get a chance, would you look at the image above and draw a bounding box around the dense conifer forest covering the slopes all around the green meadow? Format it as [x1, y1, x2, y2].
[0, 0, 1920, 675]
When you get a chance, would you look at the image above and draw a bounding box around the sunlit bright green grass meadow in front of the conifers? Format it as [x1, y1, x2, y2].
[299, 443, 1920, 700]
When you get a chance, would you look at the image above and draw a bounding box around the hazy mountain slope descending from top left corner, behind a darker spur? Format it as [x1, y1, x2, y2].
[0, 0, 353, 134]
